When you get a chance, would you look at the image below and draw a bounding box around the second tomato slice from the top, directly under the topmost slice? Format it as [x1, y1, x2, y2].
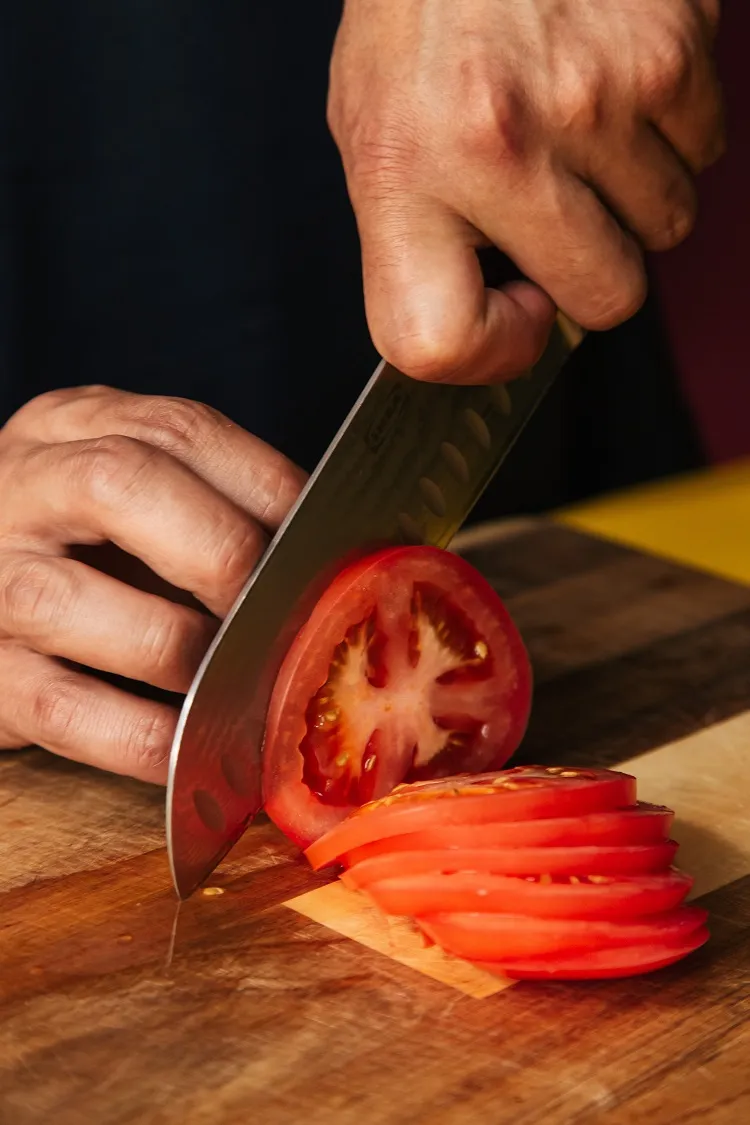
[346, 802, 675, 864]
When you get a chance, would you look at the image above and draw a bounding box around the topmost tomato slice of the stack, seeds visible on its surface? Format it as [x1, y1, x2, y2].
[306, 766, 635, 874]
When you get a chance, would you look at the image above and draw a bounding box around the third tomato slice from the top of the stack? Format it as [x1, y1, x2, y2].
[342, 840, 677, 890]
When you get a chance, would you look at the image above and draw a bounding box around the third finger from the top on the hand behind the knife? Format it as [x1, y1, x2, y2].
[0, 554, 216, 693]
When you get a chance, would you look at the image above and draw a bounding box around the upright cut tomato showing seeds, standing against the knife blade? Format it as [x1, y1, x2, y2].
[263, 547, 531, 844]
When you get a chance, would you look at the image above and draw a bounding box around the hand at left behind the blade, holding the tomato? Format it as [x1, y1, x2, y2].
[0, 387, 304, 782]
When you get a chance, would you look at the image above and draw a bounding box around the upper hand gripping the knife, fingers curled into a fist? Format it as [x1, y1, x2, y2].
[328, 0, 723, 383]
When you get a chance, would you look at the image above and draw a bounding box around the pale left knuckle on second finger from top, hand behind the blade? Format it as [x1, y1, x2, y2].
[71, 433, 160, 507]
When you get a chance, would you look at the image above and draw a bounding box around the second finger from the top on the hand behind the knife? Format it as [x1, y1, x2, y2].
[2, 435, 265, 617]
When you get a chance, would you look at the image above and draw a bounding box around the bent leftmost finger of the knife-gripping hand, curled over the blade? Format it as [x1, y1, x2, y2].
[358, 195, 554, 383]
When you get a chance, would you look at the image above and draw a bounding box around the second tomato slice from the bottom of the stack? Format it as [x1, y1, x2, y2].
[418, 907, 708, 963]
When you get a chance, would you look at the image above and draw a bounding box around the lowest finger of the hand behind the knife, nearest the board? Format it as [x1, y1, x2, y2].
[0, 642, 178, 785]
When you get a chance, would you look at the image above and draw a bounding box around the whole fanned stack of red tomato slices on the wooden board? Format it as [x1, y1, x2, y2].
[306, 766, 708, 980]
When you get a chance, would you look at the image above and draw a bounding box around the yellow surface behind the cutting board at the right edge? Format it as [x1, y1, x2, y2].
[557, 460, 750, 584]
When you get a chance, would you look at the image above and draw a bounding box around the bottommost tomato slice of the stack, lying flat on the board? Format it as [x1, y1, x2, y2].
[475, 926, 711, 981]
